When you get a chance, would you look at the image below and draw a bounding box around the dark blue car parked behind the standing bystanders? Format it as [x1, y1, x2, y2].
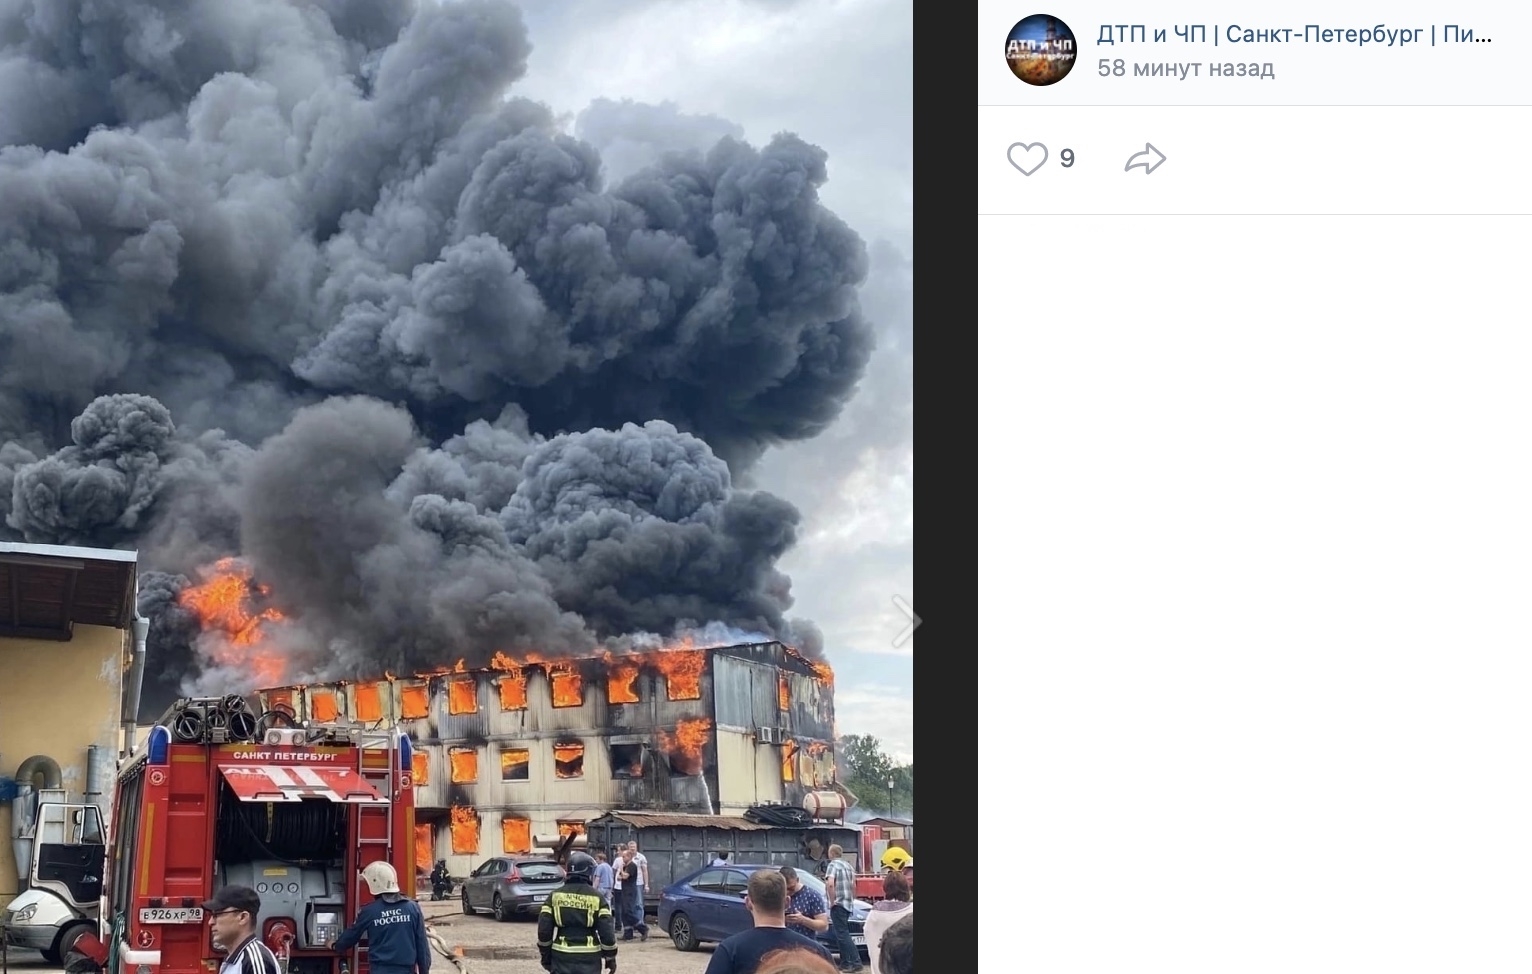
[659, 862, 872, 957]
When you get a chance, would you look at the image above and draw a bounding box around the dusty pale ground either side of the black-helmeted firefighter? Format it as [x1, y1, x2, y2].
[420, 899, 712, 974]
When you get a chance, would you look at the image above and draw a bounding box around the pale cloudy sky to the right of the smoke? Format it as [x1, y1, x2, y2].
[513, 0, 919, 761]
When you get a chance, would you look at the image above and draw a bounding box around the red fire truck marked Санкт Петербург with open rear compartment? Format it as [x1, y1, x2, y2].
[77, 695, 415, 974]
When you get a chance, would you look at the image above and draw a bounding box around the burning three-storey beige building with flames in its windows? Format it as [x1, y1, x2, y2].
[259, 642, 835, 874]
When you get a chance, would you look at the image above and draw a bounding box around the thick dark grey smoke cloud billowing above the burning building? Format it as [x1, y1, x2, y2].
[0, 0, 872, 711]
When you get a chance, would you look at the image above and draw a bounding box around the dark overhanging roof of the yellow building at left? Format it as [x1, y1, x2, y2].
[0, 541, 138, 642]
